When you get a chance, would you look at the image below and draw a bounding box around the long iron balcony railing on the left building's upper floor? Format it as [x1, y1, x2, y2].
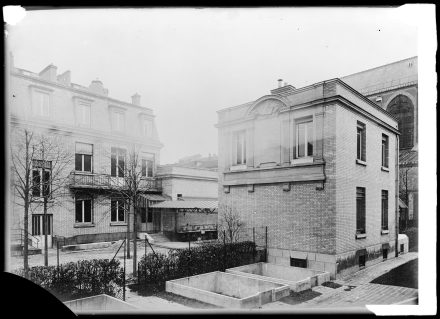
[69, 172, 162, 192]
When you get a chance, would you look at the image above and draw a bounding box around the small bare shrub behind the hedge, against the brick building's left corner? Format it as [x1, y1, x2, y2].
[218, 205, 244, 243]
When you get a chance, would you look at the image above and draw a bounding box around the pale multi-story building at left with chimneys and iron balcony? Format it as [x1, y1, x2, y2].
[7, 56, 162, 245]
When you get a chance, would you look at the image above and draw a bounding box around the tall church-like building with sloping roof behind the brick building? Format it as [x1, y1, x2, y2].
[341, 57, 419, 229]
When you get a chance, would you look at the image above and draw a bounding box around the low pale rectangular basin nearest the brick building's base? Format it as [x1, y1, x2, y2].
[226, 262, 330, 292]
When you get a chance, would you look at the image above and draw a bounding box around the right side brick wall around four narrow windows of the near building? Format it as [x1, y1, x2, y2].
[335, 107, 396, 254]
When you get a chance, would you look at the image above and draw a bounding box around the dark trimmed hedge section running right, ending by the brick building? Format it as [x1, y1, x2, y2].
[138, 241, 265, 290]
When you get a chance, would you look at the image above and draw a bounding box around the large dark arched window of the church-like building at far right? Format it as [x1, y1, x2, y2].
[387, 95, 414, 149]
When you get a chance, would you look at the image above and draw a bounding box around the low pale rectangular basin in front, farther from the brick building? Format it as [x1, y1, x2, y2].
[166, 271, 290, 308]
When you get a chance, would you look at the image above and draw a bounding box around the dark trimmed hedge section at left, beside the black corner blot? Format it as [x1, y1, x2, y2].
[15, 259, 124, 301]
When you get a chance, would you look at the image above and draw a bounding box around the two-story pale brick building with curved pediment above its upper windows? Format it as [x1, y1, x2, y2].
[217, 79, 399, 277]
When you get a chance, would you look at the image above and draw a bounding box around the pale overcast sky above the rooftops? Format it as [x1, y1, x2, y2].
[8, 8, 418, 164]
